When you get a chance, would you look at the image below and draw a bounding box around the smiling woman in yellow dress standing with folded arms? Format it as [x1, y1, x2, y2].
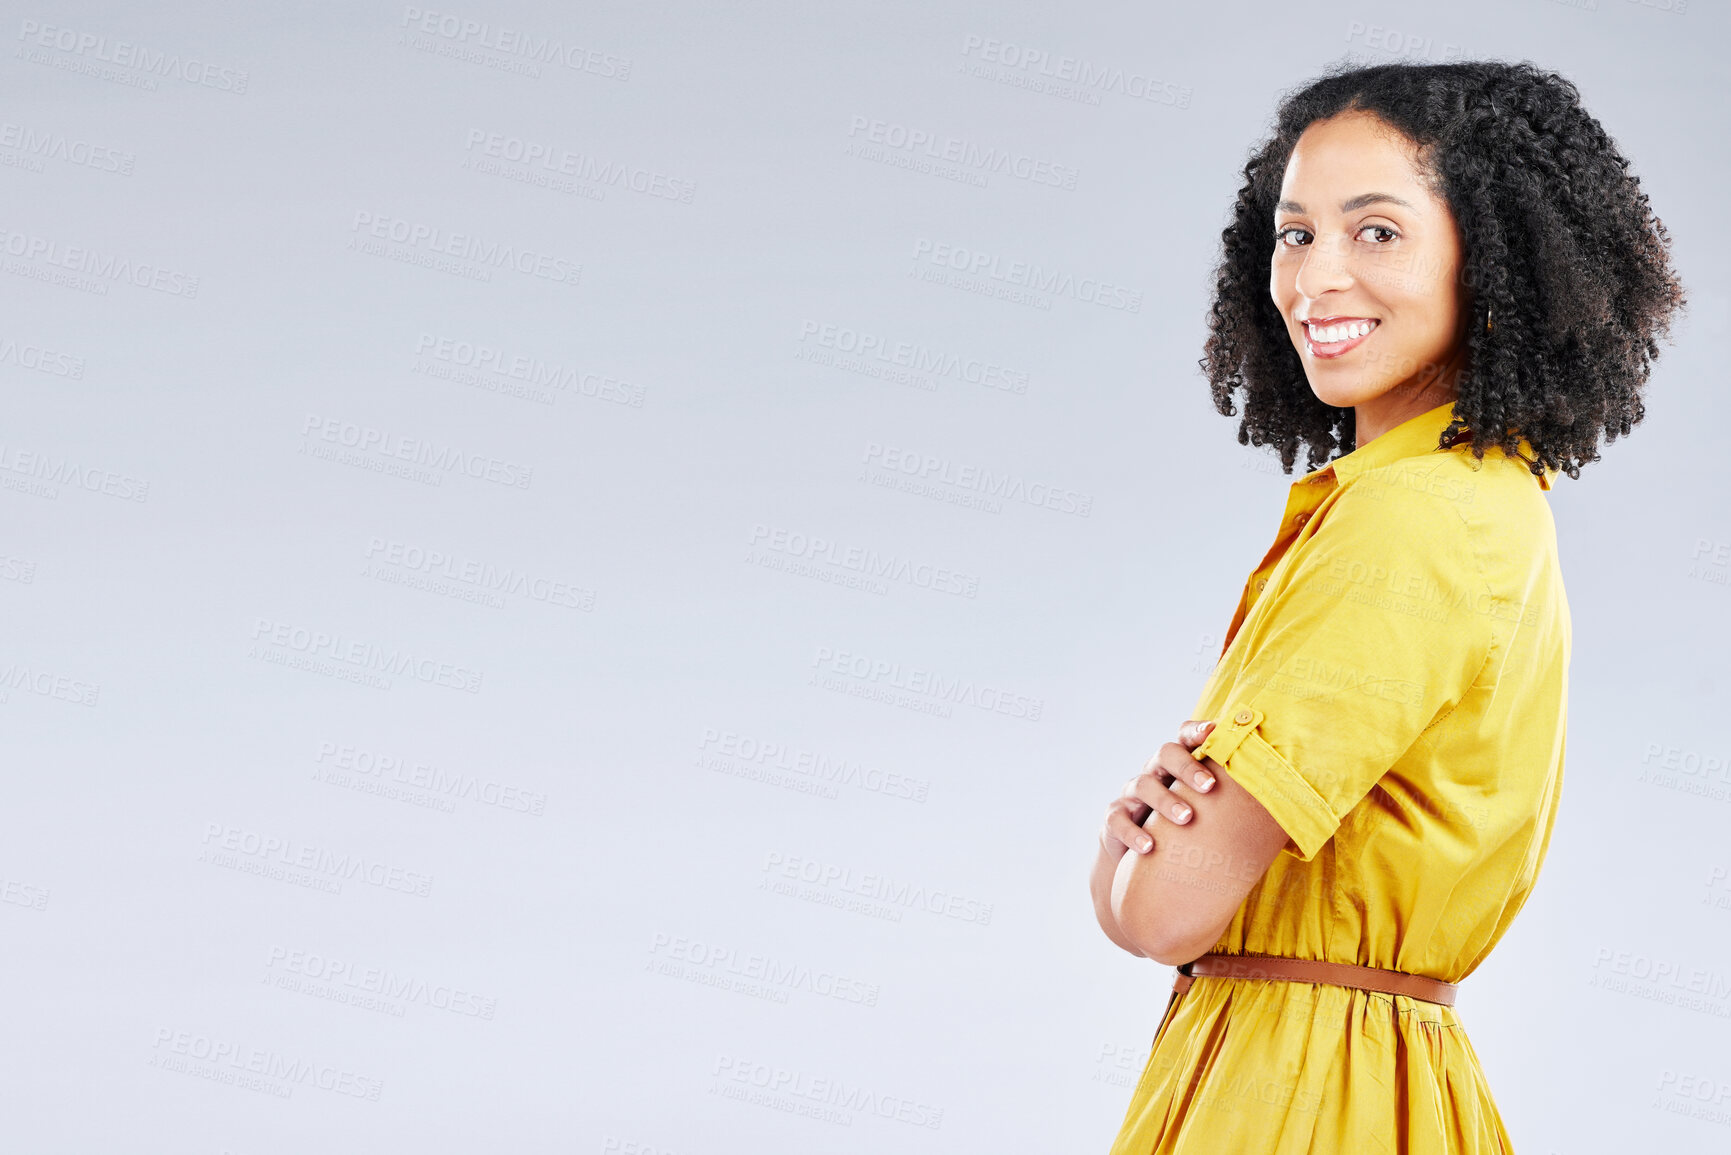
[1092, 62, 1684, 1155]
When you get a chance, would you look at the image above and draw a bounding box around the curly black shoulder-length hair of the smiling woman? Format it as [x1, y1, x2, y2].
[1200, 61, 1686, 478]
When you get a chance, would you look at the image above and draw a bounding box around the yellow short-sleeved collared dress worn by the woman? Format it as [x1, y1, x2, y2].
[1111, 405, 1570, 1155]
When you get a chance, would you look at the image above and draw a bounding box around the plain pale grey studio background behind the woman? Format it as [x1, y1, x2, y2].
[0, 0, 1731, 1155]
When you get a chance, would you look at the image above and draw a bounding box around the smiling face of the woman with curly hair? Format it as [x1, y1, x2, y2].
[1269, 113, 1471, 420]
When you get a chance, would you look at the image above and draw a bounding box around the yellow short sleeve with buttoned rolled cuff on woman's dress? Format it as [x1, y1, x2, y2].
[1193, 474, 1494, 862]
